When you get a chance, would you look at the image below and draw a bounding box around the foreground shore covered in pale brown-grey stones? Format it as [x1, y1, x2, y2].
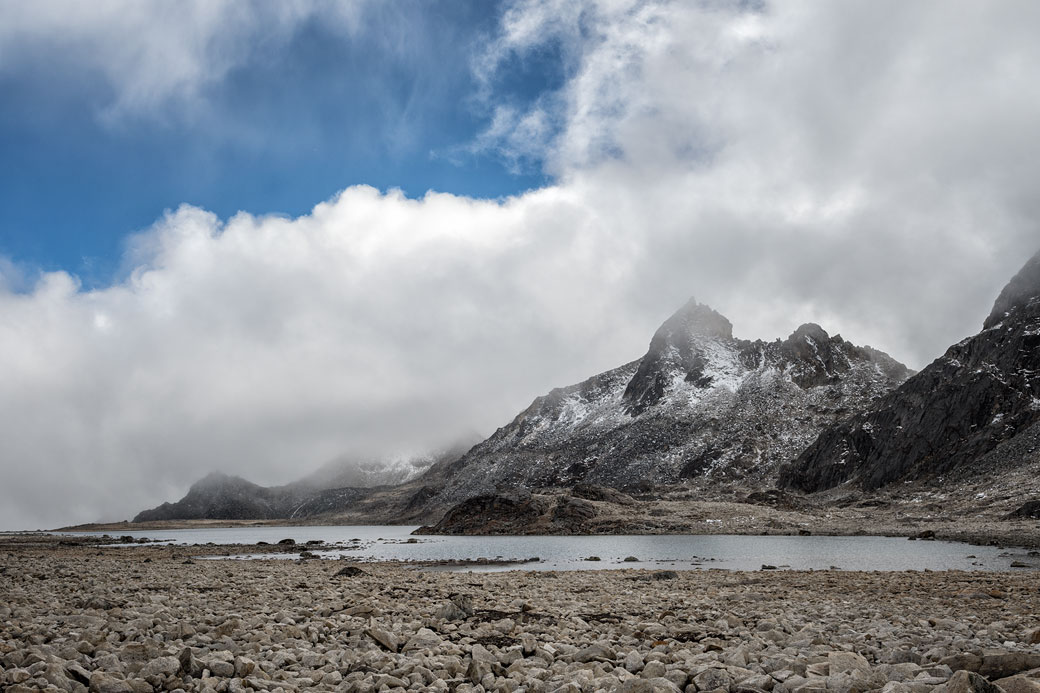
[0, 536, 1040, 693]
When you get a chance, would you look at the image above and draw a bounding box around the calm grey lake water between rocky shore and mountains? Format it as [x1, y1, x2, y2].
[69, 525, 1040, 570]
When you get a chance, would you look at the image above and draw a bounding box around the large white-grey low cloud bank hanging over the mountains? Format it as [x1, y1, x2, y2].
[0, 0, 1040, 528]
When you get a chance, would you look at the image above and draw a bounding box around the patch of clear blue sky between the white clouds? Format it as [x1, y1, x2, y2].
[0, 0, 565, 286]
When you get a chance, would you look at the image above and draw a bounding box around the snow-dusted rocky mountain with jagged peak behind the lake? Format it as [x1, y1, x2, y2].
[426, 300, 910, 507]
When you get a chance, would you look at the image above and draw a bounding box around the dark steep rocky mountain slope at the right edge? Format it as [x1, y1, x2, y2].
[779, 248, 1040, 492]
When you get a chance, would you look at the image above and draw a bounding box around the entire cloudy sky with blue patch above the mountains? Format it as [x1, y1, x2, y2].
[0, 0, 1040, 529]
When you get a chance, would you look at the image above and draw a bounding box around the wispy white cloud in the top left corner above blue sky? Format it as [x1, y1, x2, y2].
[0, 0, 366, 120]
